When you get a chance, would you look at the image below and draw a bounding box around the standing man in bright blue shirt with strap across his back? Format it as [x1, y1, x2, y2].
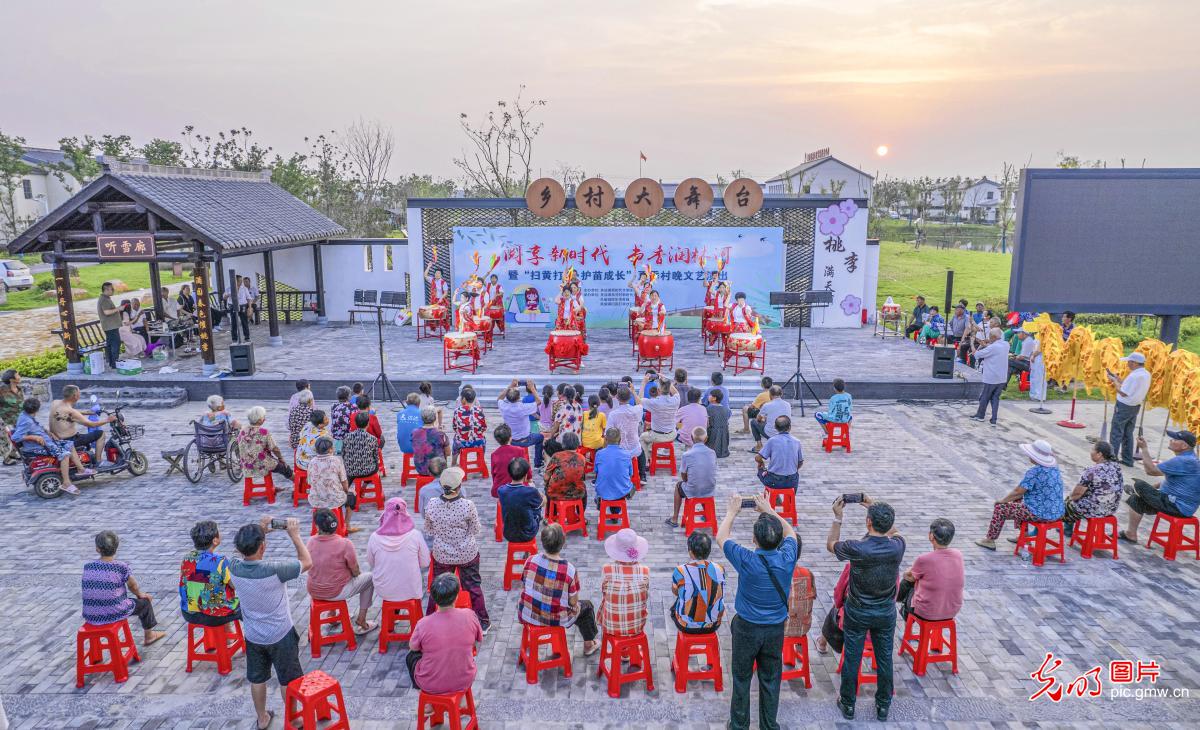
[716, 495, 800, 730]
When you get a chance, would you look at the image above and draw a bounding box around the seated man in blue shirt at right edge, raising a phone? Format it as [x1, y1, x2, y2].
[1118, 431, 1200, 543]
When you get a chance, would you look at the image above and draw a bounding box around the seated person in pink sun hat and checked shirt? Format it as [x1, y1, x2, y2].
[600, 527, 650, 636]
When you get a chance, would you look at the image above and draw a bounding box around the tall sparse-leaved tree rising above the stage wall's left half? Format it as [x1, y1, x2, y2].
[454, 84, 546, 198]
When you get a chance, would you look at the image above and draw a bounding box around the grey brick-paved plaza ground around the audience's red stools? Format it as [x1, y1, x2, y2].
[0, 394, 1200, 729]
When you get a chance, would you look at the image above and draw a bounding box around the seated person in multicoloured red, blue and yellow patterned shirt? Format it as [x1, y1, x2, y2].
[179, 520, 241, 626]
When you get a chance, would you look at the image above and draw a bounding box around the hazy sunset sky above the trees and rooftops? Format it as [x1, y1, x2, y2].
[0, 0, 1200, 181]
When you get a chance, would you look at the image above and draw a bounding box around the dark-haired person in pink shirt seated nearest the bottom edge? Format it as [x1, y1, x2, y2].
[404, 573, 484, 694]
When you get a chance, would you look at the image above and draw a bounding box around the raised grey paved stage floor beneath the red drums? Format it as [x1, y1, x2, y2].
[52, 322, 982, 406]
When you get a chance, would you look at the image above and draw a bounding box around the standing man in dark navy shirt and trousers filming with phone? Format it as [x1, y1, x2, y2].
[826, 495, 905, 723]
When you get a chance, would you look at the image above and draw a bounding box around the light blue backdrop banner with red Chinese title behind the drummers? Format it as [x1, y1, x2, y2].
[451, 226, 782, 329]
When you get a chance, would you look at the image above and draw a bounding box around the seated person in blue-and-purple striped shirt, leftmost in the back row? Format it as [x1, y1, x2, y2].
[82, 529, 167, 646]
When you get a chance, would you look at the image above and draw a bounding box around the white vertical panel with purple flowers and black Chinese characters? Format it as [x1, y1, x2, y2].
[812, 199, 875, 327]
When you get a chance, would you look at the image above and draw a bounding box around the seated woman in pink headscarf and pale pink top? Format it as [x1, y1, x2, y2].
[367, 497, 430, 600]
